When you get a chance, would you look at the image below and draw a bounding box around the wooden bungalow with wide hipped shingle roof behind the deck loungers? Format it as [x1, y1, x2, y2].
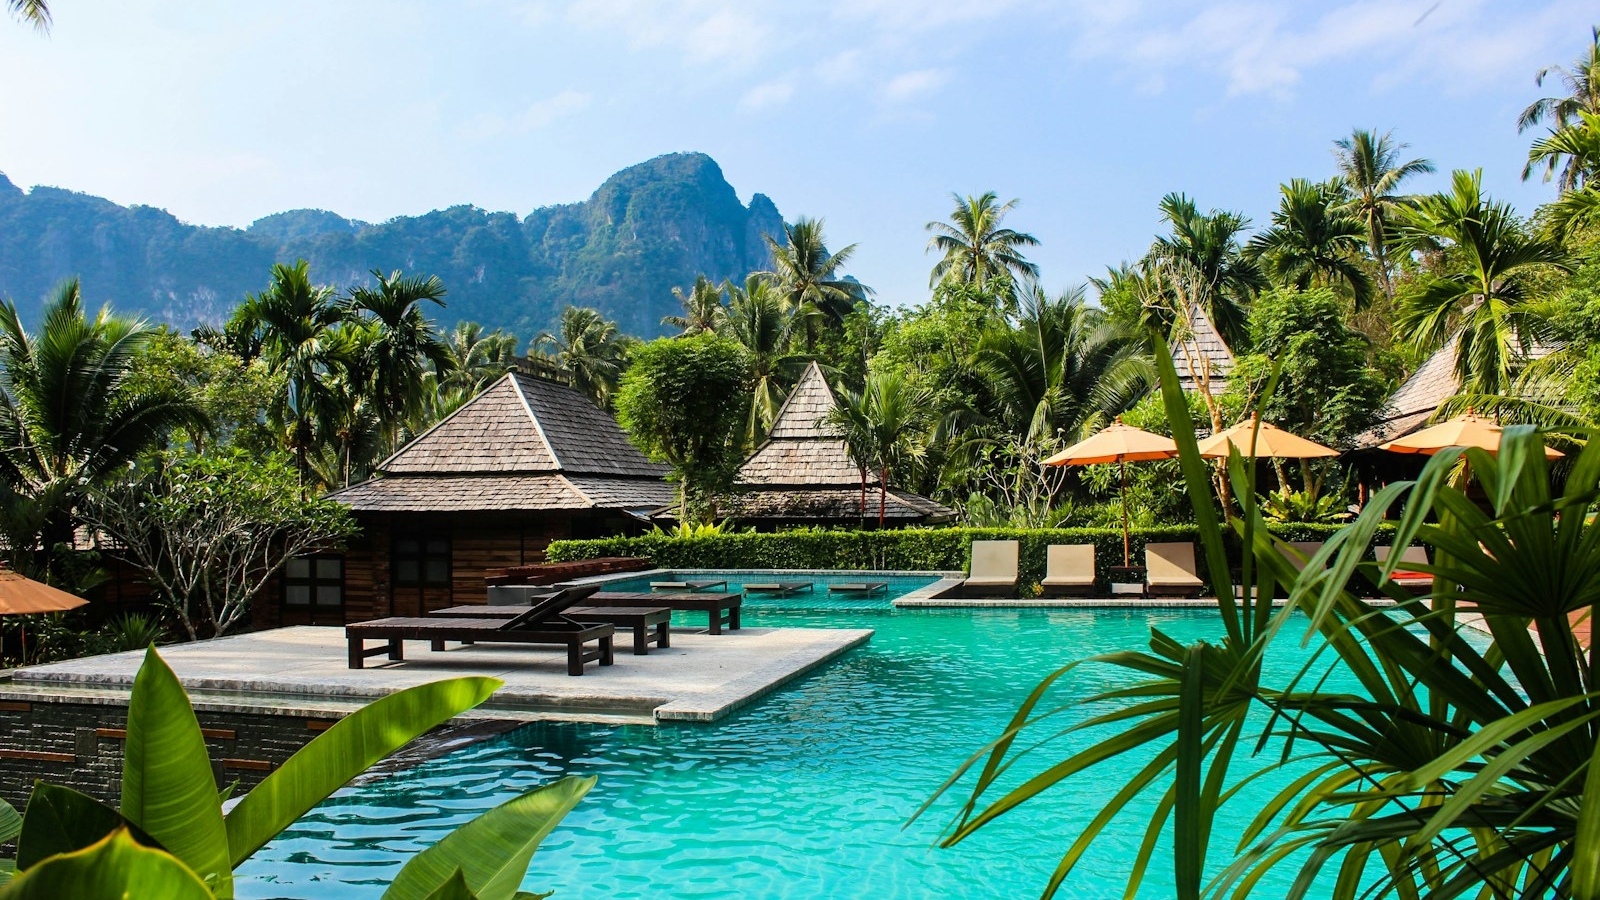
[254, 372, 675, 626]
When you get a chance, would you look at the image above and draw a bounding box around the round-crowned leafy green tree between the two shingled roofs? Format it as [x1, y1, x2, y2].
[616, 333, 750, 517]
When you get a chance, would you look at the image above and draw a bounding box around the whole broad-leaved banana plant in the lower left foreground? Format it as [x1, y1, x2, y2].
[0, 649, 595, 900]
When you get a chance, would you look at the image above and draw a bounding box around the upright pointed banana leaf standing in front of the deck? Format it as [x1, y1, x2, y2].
[122, 647, 234, 900]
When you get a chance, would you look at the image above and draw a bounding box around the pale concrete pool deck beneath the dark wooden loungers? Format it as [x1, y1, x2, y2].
[0, 626, 872, 722]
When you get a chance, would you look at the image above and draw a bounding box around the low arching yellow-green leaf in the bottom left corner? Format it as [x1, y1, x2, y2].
[5, 830, 211, 900]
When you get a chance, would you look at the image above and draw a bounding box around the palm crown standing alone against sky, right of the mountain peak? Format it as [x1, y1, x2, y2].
[926, 191, 1038, 295]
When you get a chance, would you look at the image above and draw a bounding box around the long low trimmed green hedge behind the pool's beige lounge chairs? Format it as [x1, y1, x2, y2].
[546, 525, 1388, 588]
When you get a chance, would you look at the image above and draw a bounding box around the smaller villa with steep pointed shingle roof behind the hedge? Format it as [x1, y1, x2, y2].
[717, 362, 955, 528]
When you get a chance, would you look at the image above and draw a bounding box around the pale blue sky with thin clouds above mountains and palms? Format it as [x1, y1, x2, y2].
[0, 0, 1600, 303]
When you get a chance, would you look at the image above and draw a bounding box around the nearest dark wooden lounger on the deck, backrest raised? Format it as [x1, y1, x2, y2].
[344, 591, 616, 676]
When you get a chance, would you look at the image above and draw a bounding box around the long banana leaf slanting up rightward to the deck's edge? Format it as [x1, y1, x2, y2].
[226, 677, 504, 866]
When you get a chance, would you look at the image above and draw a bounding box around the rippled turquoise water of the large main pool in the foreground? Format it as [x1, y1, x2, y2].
[238, 609, 1337, 900]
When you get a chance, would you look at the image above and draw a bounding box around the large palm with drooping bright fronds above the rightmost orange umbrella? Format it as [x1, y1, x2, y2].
[1398, 170, 1570, 394]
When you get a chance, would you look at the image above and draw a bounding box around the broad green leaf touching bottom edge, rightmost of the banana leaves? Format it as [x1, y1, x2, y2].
[382, 777, 595, 900]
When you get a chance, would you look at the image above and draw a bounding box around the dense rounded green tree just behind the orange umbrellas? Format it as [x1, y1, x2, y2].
[1229, 288, 1387, 447]
